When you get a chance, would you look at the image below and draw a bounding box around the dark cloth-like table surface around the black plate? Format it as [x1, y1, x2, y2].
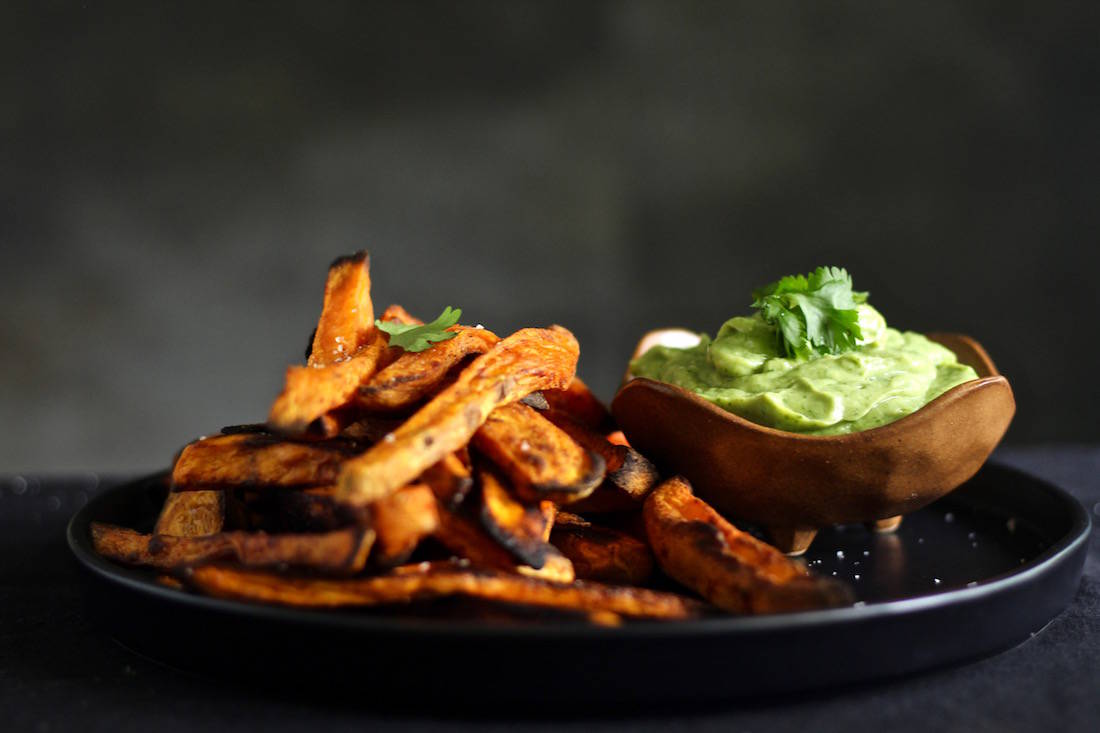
[0, 446, 1100, 733]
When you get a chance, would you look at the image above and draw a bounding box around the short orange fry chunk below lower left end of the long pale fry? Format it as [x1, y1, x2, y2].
[370, 483, 439, 568]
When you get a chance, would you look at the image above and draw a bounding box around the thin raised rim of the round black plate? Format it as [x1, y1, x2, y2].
[65, 461, 1092, 641]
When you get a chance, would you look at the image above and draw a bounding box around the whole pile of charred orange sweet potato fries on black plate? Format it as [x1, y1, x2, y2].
[92, 253, 849, 625]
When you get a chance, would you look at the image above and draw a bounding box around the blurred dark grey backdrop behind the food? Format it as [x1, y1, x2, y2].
[0, 1, 1100, 472]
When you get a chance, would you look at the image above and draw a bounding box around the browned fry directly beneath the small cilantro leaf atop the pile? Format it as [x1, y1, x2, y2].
[355, 326, 501, 413]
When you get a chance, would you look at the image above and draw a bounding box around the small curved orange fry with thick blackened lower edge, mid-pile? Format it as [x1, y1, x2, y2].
[477, 469, 553, 569]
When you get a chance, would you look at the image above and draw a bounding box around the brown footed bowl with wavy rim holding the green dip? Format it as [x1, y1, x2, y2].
[612, 329, 1015, 555]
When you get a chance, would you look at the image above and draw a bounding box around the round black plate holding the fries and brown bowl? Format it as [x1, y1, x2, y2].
[68, 464, 1090, 703]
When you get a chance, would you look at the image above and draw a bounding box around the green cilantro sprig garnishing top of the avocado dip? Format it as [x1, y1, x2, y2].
[752, 267, 867, 359]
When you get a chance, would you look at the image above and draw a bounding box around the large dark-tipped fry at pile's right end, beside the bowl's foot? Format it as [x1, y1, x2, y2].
[644, 477, 851, 613]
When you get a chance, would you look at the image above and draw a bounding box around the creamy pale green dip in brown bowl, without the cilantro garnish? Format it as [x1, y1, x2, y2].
[630, 304, 978, 435]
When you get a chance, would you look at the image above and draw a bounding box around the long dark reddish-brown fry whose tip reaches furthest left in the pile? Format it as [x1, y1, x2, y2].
[91, 522, 374, 573]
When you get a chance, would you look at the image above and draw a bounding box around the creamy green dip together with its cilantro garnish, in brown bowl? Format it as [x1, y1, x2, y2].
[630, 267, 978, 435]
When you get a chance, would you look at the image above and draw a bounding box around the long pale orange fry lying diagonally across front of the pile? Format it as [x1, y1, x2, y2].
[338, 326, 579, 506]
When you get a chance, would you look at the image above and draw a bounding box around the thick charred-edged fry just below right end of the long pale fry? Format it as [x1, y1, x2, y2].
[472, 403, 605, 503]
